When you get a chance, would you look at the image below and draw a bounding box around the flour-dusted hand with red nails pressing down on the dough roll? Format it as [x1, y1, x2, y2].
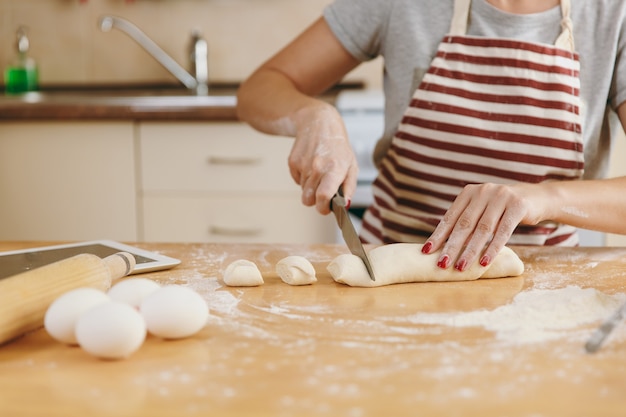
[422, 183, 543, 271]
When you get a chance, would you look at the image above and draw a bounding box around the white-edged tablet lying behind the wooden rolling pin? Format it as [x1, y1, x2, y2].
[0, 240, 180, 279]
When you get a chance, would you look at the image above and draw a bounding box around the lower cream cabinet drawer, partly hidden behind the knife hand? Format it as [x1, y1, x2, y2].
[143, 195, 336, 243]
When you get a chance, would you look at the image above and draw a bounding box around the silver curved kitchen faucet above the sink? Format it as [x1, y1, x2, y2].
[99, 15, 209, 95]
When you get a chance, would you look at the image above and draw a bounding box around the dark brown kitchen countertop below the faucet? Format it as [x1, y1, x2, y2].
[0, 82, 363, 121]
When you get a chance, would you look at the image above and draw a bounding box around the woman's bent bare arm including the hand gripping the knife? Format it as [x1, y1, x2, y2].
[237, 17, 360, 214]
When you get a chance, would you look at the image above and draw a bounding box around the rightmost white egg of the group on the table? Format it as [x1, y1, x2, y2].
[139, 285, 209, 339]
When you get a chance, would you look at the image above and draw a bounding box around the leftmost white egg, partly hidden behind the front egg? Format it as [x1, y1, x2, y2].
[43, 288, 111, 345]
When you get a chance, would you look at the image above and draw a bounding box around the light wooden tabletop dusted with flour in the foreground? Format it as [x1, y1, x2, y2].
[0, 242, 626, 417]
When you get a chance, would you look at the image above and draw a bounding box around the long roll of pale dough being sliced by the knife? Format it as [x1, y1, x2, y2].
[327, 243, 524, 287]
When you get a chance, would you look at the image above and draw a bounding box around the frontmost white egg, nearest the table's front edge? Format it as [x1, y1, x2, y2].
[76, 301, 146, 359]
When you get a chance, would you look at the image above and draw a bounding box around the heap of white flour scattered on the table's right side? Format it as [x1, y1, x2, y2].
[407, 286, 626, 344]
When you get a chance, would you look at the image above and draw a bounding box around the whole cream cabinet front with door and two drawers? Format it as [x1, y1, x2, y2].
[0, 121, 336, 243]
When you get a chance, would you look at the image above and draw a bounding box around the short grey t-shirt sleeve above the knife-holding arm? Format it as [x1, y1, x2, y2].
[324, 0, 393, 61]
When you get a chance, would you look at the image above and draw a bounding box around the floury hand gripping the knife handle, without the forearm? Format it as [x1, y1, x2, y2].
[288, 102, 358, 214]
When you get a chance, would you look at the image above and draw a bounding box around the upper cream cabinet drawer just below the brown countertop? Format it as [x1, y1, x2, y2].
[139, 122, 298, 191]
